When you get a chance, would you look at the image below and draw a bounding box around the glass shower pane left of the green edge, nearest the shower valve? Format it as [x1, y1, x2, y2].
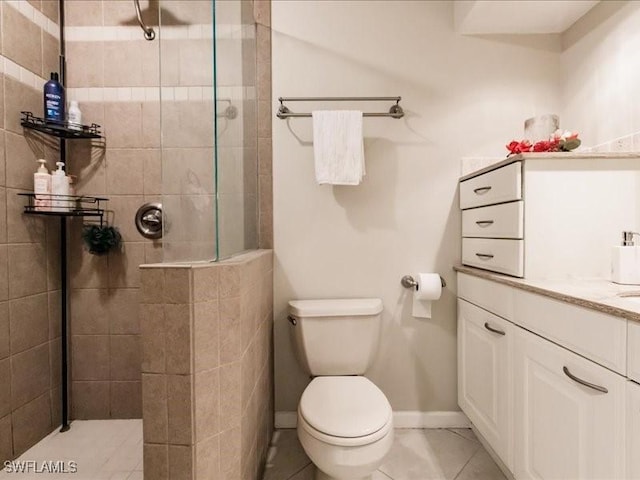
[158, 0, 218, 262]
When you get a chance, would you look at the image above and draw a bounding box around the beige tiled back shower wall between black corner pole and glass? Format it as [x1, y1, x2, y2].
[65, 0, 161, 419]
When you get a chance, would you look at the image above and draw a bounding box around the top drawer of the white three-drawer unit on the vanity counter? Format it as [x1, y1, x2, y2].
[460, 162, 522, 209]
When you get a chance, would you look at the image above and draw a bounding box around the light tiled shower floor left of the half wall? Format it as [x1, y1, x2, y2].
[0, 420, 143, 480]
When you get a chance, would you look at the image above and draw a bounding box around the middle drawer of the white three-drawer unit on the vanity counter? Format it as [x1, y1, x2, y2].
[462, 201, 524, 238]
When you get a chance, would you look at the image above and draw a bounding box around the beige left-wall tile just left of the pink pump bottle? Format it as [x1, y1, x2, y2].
[4, 132, 43, 191]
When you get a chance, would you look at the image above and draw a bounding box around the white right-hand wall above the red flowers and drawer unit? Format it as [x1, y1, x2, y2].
[560, 1, 640, 146]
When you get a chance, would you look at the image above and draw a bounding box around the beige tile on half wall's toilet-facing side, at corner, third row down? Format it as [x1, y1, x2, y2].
[194, 368, 220, 441]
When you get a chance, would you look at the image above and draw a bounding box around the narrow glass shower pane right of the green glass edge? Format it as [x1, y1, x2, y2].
[215, 0, 258, 258]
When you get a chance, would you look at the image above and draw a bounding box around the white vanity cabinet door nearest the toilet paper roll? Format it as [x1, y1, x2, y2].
[458, 299, 513, 469]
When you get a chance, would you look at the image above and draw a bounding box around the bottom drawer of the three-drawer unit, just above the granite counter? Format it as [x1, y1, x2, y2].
[462, 238, 524, 277]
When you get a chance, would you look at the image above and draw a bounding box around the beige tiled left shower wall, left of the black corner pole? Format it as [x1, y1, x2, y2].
[0, 0, 61, 461]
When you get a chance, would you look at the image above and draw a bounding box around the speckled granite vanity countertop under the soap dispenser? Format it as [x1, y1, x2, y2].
[453, 265, 640, 322]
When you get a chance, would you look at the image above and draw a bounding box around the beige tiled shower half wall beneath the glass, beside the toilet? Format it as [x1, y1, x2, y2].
[140, 250, 273, 480]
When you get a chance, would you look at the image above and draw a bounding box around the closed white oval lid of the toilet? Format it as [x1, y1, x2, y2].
[299, 376, 391, 438]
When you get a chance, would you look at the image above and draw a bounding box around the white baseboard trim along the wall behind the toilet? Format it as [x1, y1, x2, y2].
[275, 410, 471, 428]
